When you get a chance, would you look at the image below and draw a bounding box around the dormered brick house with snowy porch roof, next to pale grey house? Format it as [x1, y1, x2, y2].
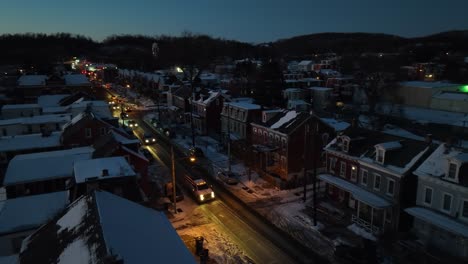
[319, 126, 432, 235]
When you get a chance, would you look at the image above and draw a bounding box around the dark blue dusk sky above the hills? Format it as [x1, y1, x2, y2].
[0, 0, 468, 43]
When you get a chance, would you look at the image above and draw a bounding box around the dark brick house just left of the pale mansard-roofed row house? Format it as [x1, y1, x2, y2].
[188, 91, 229, 135]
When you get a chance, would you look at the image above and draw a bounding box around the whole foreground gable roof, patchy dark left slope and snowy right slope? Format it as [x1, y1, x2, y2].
[20, 191, 195, 264]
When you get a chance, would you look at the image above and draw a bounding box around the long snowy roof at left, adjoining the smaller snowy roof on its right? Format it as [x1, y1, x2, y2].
[3, 147, 94, 186]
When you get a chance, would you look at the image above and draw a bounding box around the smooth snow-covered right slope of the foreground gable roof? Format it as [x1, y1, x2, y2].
[95, 191, 195, 264]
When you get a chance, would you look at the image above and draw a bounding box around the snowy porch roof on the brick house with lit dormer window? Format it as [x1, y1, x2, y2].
[319, 174, 392, 209]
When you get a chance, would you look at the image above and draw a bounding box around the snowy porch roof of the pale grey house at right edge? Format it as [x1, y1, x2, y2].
[405, 207, 468, 237]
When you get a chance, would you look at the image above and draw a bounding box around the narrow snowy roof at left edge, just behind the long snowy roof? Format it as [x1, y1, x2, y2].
[0, 131, 62, 152]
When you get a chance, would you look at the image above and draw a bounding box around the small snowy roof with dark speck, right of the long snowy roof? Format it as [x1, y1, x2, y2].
[73, 157, 136, 183]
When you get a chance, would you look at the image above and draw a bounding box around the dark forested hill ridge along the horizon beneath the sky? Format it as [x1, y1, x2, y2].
[0, 31, 468, 70]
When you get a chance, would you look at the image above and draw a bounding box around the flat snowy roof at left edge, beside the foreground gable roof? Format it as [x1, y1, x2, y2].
[0, 191, 68, 234]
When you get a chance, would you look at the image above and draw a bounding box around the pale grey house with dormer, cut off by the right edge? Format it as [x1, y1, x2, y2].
[405, 143, 468, 261]
